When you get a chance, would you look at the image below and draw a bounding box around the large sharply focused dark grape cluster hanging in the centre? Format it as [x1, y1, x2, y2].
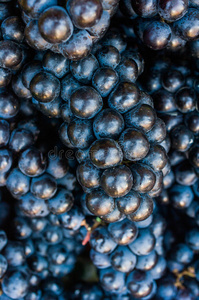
[59, 33, 168, 222]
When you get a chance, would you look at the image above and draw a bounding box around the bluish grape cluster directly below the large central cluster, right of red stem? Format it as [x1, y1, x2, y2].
[90, 214, 167, 299]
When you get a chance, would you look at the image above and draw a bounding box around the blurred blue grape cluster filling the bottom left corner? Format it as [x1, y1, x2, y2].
[0, 208, 85, 299]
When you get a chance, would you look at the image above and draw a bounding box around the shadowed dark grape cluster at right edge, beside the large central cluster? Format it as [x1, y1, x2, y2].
[139, 56, 199, 209]
